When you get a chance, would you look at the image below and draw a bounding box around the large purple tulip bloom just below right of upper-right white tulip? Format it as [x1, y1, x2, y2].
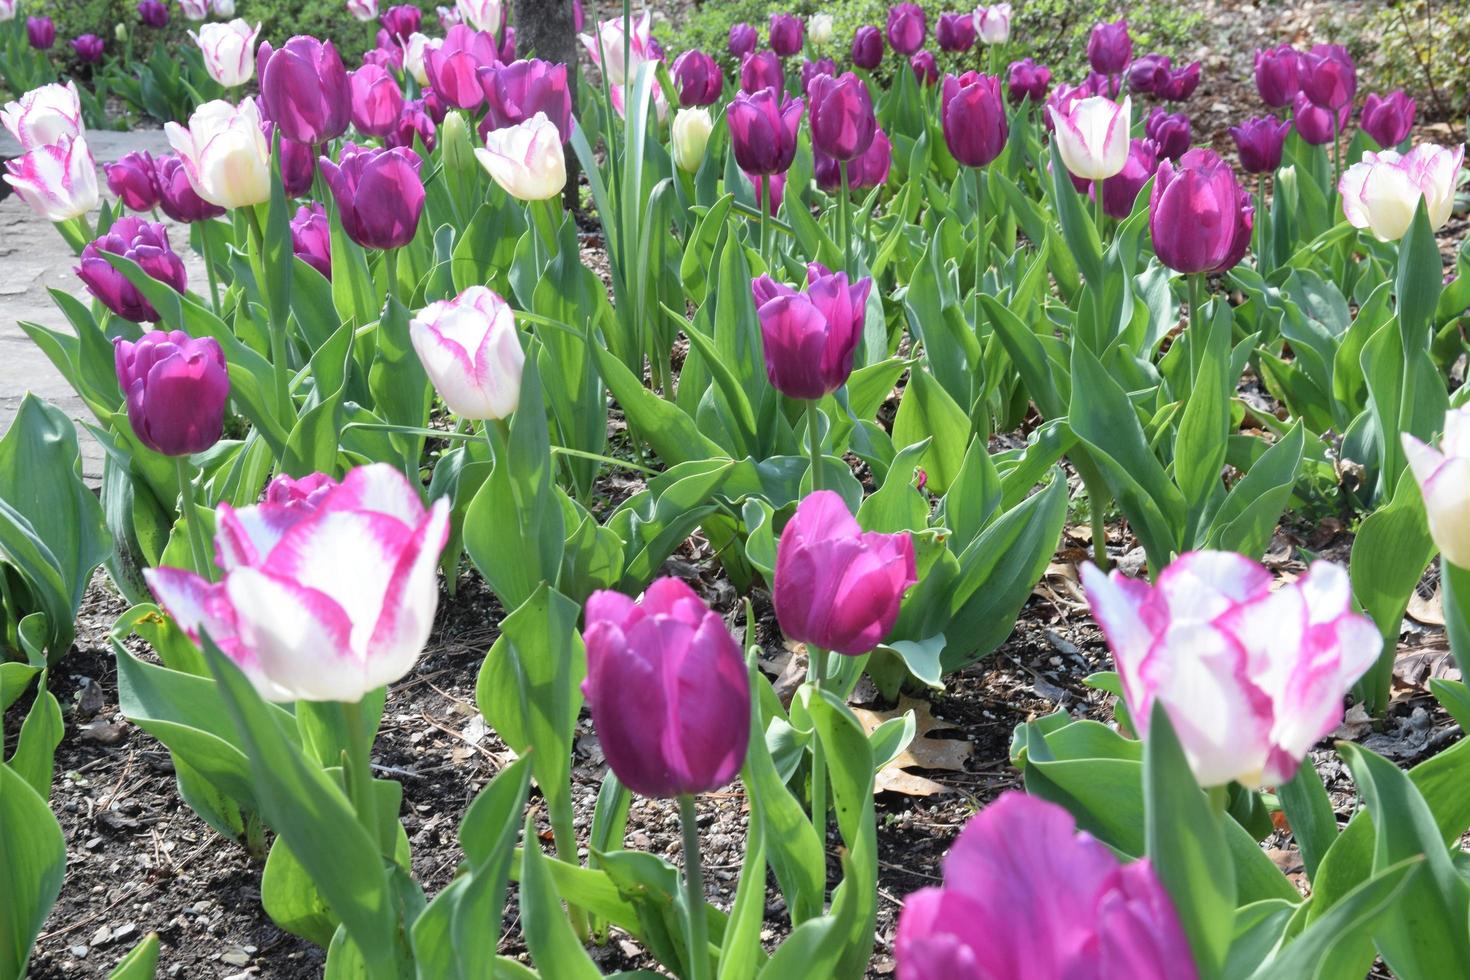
[1148, 148, 1254, 275]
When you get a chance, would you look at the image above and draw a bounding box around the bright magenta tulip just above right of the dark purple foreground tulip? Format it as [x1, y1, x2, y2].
[772, 491, 911, 655]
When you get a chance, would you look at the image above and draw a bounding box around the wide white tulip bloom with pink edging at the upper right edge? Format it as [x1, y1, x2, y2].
[1338, 143, 1464, 240]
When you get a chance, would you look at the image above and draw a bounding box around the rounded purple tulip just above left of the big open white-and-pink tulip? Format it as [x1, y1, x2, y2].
[113, 329, 229, 455]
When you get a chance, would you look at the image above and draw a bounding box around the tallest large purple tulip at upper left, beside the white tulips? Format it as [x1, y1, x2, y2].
[256, 34, 353, 145]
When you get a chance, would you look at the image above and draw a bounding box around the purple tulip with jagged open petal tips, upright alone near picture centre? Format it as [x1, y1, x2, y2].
[750, 263, 873, 399]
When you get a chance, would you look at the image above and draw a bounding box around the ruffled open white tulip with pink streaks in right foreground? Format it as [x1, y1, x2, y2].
[1082, 551, 1383, 788]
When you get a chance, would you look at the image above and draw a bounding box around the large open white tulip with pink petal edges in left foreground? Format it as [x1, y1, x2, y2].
[144, 463, 450, 704]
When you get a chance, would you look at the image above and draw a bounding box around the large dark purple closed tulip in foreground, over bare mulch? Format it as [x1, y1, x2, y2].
[582, 579, 750, 798]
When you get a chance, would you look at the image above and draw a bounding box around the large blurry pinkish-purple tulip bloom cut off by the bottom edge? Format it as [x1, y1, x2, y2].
[894, 790, 1200, 980]
